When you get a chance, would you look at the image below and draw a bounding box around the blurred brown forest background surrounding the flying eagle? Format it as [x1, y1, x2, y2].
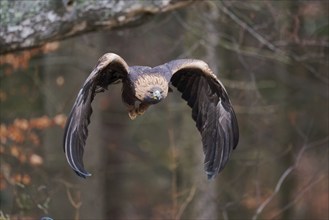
[0, 1, 329, 220]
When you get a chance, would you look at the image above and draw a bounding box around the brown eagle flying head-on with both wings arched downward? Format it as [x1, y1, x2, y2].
[64, 53, 239, 179]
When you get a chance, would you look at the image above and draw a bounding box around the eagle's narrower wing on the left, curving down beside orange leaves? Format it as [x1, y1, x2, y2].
[64, 53, 129, 178]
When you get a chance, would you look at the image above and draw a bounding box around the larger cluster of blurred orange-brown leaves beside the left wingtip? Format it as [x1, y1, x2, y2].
[0, 114, 66, 190]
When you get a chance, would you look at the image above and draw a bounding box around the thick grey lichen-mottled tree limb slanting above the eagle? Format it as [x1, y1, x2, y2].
[0, 0, 194, 54]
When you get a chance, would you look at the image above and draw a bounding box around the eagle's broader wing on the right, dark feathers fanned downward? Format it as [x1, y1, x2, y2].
[166, 59, 239, 179]
